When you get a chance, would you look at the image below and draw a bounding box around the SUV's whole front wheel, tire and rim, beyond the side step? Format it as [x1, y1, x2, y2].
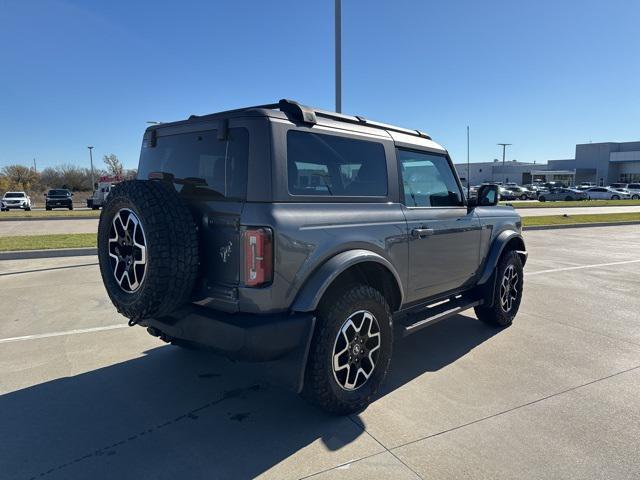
[475, 250, 524, 327]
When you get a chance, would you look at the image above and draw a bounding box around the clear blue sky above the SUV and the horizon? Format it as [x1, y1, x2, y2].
[0, 0, 640, 168]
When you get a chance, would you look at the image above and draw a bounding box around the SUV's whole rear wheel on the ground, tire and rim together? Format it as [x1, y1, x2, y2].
[302, 284, 393, 415]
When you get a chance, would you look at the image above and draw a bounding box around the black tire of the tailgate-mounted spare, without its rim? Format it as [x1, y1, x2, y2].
[98, 180, 199, 321]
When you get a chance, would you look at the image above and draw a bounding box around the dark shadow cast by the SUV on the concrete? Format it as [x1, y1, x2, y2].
[0, 315, 498, 479]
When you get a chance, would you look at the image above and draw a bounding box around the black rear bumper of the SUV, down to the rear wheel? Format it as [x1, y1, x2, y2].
[140, 305, 315, 392]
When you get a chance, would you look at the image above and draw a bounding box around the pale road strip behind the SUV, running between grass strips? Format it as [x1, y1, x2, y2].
[0, 205, 640, 237]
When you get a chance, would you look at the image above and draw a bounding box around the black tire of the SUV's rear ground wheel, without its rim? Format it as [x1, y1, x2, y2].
[302, 284, 393, 415]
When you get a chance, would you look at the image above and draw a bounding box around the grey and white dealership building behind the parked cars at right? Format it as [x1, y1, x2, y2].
[456, 141, 640, 185]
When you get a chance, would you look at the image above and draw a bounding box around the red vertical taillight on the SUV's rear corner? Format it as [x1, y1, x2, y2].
[243, 227, 273, 287]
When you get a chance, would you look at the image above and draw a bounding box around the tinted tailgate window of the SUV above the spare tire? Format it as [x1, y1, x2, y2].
[138, 128, 249, 200]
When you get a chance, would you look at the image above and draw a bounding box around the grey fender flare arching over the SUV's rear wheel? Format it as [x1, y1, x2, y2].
[291, 249, 404, 312]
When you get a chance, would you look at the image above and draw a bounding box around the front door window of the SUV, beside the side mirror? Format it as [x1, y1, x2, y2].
[398, 149, 463, 207]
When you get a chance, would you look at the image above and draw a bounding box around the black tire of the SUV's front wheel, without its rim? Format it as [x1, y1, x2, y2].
[475, 250, 524, 327]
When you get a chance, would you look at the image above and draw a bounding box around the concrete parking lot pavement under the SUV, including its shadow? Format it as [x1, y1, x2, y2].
[0, 225, 640, 480]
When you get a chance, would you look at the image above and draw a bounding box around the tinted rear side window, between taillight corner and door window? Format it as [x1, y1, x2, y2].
[287, 130, 387, 197]
